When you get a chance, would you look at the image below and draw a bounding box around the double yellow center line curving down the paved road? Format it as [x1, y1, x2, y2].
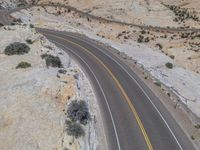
[45, 33, 153, 150]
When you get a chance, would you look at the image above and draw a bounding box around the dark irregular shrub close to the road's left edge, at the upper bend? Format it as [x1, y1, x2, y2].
[41, 54, 63, 68]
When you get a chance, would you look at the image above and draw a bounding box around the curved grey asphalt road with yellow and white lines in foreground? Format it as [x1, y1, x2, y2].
[34, 29, 195, 150]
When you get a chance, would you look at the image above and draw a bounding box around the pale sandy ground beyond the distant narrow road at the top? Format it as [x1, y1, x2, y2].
[36, 0, 200, 27]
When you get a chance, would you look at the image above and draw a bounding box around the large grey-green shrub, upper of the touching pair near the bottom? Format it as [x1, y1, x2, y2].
[67, 100, 90, 125]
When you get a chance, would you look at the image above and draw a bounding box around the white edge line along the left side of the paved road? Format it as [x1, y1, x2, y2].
[50, 40, 121, 150]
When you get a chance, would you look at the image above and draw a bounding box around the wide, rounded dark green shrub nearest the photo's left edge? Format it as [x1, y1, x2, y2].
[4, 42, 30, 55]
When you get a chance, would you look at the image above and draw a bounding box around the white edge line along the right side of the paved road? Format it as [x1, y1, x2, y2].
[54, 33, 183, 150]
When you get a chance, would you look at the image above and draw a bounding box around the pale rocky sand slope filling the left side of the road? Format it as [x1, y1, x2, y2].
[0, 26, 102, 150]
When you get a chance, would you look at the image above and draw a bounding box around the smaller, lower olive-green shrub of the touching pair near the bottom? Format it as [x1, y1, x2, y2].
[66, 121, 85, 138]
